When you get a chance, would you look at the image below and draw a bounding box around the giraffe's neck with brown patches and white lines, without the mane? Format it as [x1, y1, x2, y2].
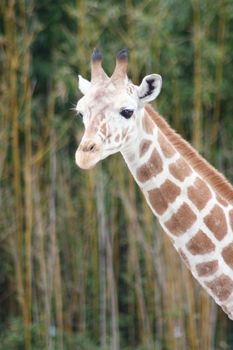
[122, 106, 233, 319]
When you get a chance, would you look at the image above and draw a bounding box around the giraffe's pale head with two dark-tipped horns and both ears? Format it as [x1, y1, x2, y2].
[75, 49, 162, 169]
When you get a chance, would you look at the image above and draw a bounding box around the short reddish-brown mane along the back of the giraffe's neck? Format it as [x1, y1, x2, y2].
[145, 105, 233, 204]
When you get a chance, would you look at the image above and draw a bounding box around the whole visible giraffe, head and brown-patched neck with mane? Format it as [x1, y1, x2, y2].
[75, 49, 233, 320]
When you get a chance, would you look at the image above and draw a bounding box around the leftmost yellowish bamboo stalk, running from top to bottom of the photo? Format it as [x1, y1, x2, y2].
[4, 0, 31, 349]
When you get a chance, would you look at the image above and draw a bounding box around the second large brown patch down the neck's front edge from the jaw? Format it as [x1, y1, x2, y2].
[148, 180, 180, 215]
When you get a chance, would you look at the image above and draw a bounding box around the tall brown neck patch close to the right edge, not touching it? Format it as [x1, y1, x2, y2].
[204, 204, 227, 241]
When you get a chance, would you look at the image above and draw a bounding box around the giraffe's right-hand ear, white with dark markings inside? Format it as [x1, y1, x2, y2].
[138, 74, 162, 105]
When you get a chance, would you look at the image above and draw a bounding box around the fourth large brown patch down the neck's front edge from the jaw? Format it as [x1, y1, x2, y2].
[186, 230, 215, 255]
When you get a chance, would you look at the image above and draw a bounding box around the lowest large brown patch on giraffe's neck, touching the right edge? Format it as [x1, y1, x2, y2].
[205, 274, 233, 301]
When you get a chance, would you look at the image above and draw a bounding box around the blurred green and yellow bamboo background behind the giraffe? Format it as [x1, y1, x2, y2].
[0, 0, 233, 350]
